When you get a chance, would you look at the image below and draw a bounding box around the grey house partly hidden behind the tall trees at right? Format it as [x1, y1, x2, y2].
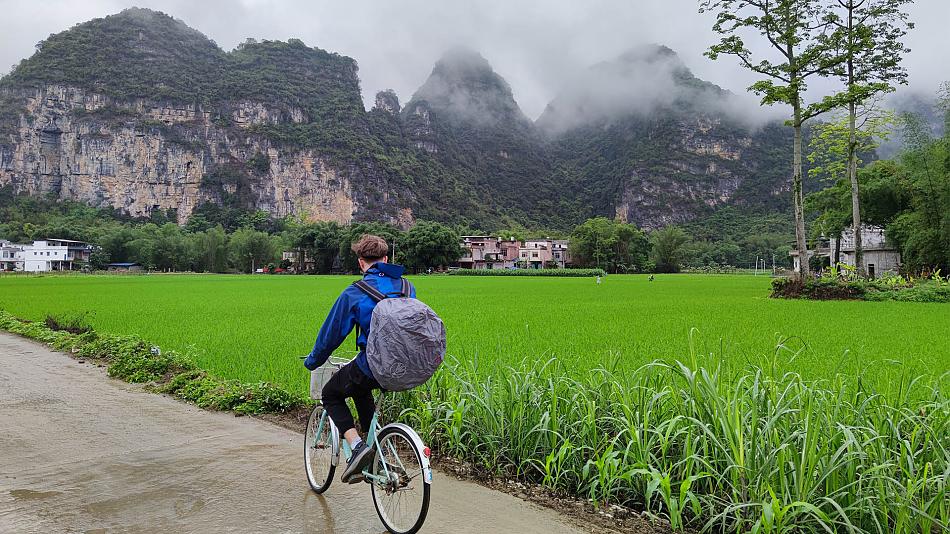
[789, 226, 901, 278]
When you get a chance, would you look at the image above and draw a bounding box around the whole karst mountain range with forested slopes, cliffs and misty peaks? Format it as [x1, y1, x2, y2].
[0, 9, 800, 234]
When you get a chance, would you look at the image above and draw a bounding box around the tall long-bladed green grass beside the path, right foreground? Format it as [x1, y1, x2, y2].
[395, 346, 950, 534]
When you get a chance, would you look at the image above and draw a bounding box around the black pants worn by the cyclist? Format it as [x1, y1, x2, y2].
[323, 361, 380, 434]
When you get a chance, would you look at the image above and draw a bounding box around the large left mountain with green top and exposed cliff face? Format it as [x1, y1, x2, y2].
[0, 10, 413, 225]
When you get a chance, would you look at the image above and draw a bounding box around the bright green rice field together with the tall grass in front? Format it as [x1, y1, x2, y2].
[0, 275, 950, 534]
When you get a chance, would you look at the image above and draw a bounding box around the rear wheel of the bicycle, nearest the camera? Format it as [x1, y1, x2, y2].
[370, 426, 430, 534]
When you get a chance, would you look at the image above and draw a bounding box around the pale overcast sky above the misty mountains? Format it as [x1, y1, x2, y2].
[0, 0, 950, 119]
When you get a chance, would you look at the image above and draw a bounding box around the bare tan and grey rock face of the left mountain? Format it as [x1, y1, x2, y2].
[0, 85, 405, 223]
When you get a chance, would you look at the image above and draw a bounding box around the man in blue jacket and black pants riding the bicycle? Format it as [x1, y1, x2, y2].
[304, 235, 416, 483]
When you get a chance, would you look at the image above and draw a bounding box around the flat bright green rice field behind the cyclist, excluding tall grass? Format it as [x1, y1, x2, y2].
[0, 275, 950, 393]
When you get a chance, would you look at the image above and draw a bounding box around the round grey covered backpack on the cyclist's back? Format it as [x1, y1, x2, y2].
[353, 278, 445, 391]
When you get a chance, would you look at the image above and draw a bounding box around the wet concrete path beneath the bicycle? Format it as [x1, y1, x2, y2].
[0, 333, 591, 534]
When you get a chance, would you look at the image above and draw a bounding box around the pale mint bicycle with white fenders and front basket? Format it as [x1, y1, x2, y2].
[304, 359, 432, 534]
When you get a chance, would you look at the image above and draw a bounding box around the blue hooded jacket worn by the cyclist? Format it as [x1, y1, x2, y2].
[303, 262, 416, 378]
